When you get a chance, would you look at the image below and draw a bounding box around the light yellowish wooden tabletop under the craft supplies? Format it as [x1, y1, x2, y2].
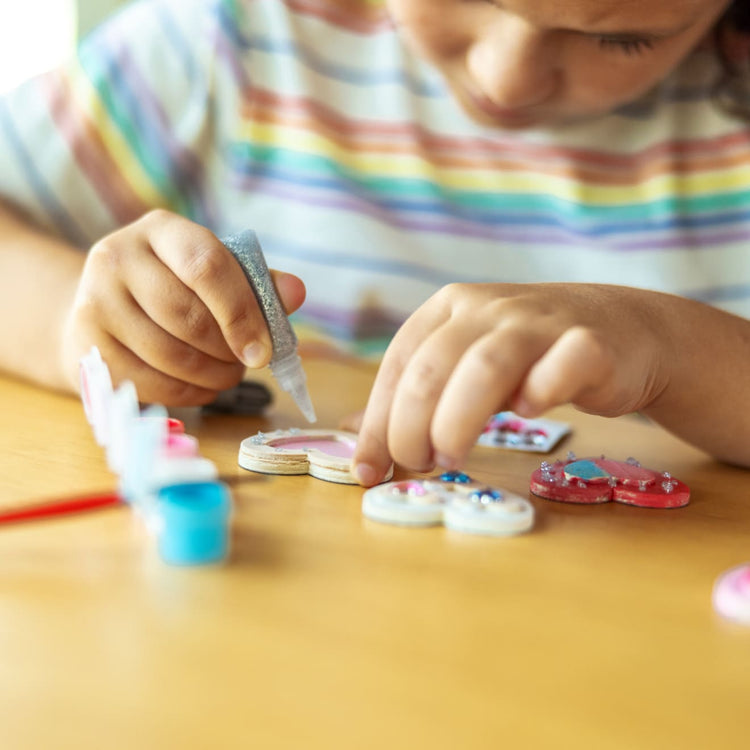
[0, 361, 750, 750]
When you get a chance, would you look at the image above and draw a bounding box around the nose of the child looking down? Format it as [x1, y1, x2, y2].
[466, 14, 560, 109]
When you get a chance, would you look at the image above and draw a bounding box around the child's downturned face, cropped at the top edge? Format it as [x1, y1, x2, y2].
[387, 0, 730, 129]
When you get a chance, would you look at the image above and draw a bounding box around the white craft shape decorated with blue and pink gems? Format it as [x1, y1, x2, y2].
[362, 472, 534, 536]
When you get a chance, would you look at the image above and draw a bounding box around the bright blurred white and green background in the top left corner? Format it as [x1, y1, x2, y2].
[0, 0, 126, 93]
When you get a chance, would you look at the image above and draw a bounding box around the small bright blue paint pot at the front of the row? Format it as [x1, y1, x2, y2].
[156, 481, 232, 565]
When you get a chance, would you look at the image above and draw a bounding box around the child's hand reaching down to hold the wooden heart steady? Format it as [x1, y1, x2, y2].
[354, 284, 670, 485]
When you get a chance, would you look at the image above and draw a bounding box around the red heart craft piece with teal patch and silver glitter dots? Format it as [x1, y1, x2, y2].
[529, 454, 690, 508]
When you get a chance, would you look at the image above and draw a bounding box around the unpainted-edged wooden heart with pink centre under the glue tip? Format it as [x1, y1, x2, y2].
[238, 428, 393, 484]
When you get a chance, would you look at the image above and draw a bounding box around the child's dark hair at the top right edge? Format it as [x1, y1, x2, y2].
[716, 0, 750, 121]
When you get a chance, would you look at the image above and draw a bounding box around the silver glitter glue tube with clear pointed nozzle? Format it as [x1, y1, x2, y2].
[222, 229, 316, 422]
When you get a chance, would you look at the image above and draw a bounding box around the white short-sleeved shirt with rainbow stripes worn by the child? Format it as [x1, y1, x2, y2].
[0, 0, 750, 354]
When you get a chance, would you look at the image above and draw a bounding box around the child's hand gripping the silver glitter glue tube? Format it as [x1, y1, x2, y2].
[63, 211, 305, 406]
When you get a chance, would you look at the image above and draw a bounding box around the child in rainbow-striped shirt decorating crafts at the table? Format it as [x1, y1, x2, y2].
[0, 0, 750, 485]
